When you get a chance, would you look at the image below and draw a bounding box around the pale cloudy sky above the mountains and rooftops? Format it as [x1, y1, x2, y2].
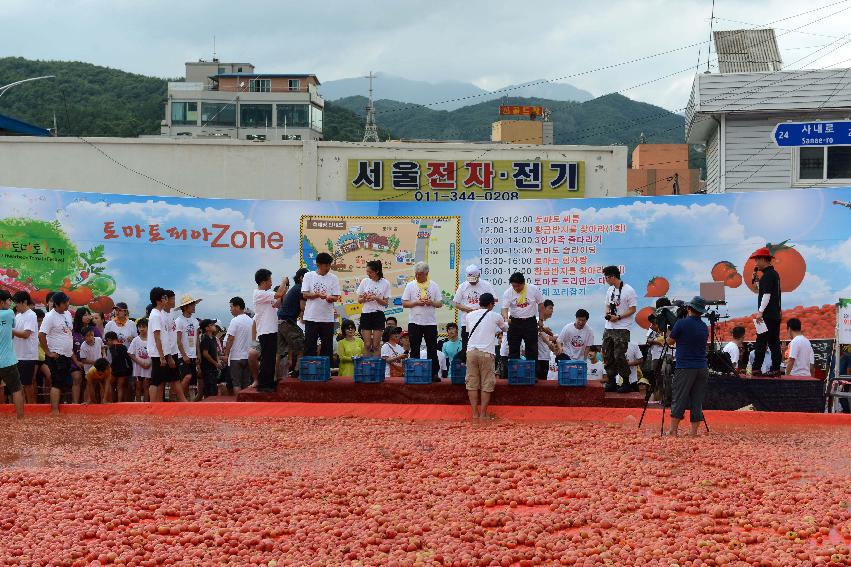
[5, 0, 851, 111]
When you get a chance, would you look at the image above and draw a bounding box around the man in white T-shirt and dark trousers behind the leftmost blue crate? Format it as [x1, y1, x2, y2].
[301, 252, 340, 361]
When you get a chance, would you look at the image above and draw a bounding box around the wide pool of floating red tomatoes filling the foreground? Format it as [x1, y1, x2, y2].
[0, 416, 851, 567]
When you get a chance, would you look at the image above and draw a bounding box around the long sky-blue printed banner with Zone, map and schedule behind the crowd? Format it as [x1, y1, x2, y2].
[0, 188, 851, 341]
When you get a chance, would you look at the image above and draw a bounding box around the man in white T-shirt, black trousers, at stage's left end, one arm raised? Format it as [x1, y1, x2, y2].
[254, 268, 290, 392]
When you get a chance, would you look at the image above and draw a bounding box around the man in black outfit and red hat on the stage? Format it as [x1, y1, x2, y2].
[751, 247, 783, 376]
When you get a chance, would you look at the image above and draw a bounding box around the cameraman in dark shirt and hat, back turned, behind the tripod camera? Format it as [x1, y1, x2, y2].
[668, 296, 709, 437]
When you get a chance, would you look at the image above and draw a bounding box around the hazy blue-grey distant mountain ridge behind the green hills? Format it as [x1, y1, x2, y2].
[319, 73, 594, 110]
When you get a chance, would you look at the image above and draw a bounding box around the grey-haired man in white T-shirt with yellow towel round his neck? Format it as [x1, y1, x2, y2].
[402, 262, 443, 382]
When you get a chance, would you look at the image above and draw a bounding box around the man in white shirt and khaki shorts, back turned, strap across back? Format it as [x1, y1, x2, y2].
[465, 293, 506, 419]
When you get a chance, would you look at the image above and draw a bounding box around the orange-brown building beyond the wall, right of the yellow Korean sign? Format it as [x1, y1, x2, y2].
[626, 144, 700, 196]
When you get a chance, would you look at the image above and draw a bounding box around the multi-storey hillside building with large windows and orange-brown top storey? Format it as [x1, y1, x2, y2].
[160, 59, 325, 140]
